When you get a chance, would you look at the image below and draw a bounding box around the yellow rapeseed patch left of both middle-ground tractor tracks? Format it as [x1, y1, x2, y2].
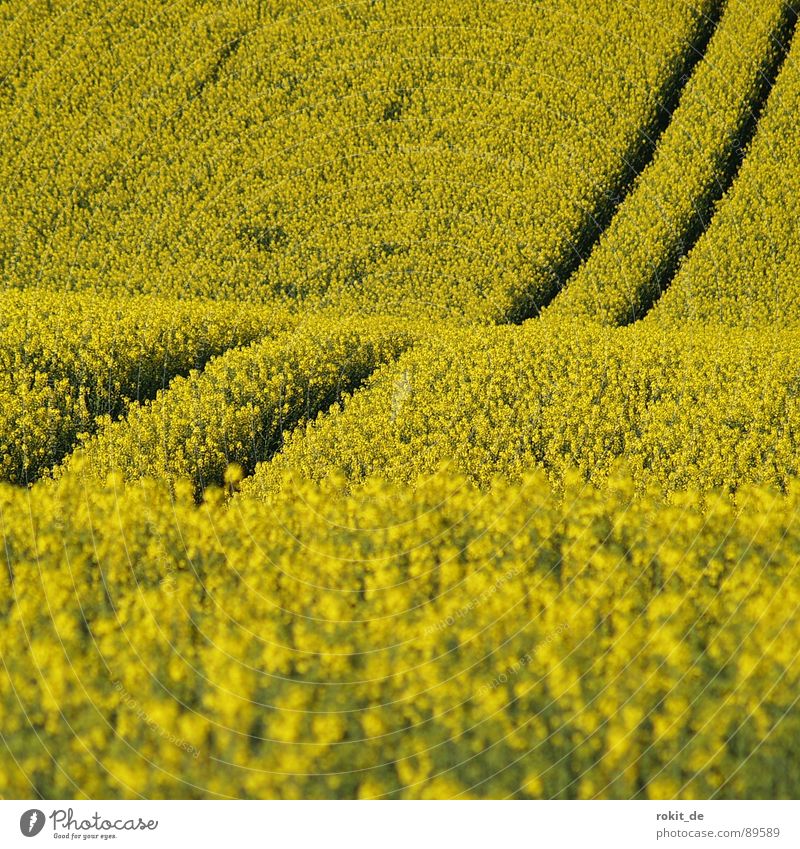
[0, 289, 290, 483]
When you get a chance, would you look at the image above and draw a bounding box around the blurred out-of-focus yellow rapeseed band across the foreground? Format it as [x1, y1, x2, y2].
[0, 471, 800, 798]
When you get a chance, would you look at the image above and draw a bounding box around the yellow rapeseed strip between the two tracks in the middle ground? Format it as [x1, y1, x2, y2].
[68, 317, 430, 493]
